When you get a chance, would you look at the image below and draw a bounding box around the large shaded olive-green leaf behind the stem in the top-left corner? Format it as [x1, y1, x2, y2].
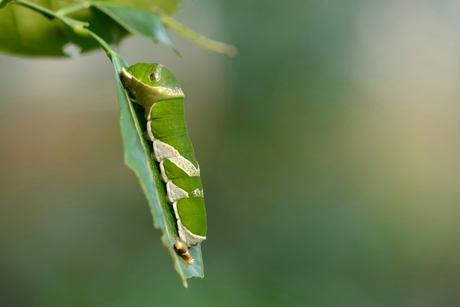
[0, 0, 180, 57]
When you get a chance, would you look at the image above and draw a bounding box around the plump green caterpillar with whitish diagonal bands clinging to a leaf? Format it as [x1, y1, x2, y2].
[120, 63, 206, 264]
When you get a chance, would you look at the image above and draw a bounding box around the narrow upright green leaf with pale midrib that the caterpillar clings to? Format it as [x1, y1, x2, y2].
[109, 51, 204, 288]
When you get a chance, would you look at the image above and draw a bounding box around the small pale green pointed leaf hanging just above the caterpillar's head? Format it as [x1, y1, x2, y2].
[90, 2, 179, 54]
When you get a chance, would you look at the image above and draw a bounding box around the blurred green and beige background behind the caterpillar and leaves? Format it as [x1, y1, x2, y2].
[0, 0, 460, 307]
